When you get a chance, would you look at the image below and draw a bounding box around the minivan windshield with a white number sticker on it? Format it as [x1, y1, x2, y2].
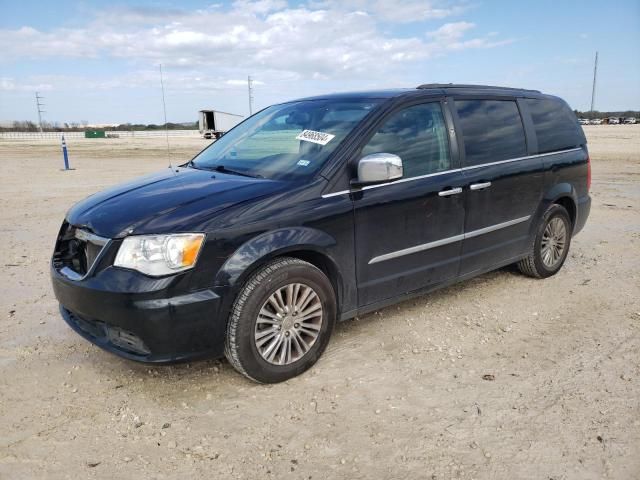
[190, 99, 379, 180]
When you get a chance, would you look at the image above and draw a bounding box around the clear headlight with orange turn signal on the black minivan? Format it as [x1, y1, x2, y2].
[114, 233, 204, 277]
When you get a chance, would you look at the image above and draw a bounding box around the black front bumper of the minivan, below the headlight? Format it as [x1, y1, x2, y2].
[51, 266, 226, 363]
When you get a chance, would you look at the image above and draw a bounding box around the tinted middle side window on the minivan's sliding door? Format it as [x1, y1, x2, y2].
[455, 100, 527, 166]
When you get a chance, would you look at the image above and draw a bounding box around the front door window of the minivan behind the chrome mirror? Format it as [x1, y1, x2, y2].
[362, 103, 451, 178]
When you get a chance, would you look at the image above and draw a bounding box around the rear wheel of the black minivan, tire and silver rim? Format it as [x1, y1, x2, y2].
[517, 204, 573, 278]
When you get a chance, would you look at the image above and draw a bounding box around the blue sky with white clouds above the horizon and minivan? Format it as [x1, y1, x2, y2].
[0, 0, 640, 123]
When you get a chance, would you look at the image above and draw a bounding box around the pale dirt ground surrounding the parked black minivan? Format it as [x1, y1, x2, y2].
[0, 125, 640, 480]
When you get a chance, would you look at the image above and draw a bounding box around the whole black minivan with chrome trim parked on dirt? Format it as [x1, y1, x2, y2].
[51, 84, 591, 382]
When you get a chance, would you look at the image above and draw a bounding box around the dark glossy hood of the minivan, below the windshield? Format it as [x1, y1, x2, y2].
[67, 168, 284, 238]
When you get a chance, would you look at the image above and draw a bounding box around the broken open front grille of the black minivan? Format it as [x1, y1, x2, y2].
[53, 222, 109, 280]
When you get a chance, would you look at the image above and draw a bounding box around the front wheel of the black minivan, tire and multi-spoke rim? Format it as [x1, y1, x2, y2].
[225, 257, 337, 383]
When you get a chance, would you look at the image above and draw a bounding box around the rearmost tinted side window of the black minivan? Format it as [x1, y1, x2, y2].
[525, 98, 584, 153]
